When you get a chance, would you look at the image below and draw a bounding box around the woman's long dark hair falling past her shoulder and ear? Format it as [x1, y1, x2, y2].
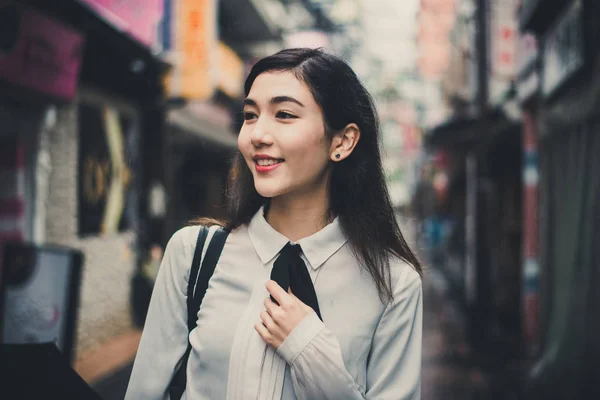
[218, 49, 422, 302]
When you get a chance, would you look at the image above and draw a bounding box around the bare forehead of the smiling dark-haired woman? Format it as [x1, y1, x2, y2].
[248, 71, 314, 105]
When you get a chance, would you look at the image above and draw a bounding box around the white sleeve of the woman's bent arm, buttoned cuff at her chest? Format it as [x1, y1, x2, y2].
[277, 268, 423, 400]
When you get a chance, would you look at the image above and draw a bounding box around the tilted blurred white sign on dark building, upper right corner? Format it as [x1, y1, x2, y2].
[542, 0, 585, 96]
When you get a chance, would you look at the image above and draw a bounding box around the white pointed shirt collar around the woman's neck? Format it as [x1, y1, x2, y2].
[248, 207, 348, 269]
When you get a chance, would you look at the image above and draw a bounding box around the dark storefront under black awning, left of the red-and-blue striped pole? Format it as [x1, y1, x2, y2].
[427, 109, 522, 350]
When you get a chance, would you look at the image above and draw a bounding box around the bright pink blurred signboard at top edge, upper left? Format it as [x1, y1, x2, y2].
[79, 0, 163, 47]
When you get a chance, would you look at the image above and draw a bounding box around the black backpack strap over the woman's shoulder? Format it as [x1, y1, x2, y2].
[169, 227, 229, 400]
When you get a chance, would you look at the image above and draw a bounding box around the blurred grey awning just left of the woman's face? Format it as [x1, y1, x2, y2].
[167, 106, 237, 151]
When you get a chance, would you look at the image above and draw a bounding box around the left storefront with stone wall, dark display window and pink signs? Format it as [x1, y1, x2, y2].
[0, 0, 164, 356]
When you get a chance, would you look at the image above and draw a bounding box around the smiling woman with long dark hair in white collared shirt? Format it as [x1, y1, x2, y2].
[127, 49, 422, 400]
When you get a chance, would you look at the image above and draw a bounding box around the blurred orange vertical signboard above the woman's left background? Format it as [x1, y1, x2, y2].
[163, 0, 218, 100]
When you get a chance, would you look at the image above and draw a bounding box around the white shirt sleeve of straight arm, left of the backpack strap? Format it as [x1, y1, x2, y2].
[125, 227, 195, 400]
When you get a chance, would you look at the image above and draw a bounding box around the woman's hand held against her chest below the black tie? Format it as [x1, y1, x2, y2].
[254, 281, 314, 350]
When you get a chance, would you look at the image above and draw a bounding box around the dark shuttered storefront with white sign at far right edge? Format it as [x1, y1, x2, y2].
[522, 0, 600, 399]
